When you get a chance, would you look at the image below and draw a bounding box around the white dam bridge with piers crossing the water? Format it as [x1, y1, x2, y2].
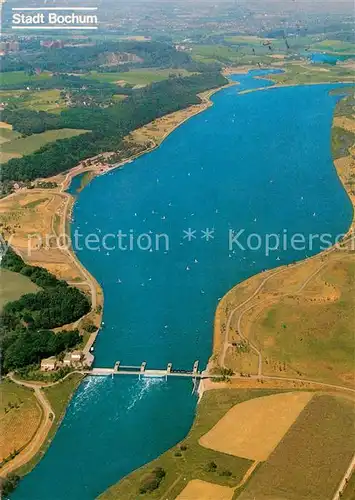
[87, 361, 209, 379]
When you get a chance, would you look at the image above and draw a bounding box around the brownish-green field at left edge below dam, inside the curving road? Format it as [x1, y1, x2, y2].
[0, 380, 42, 462]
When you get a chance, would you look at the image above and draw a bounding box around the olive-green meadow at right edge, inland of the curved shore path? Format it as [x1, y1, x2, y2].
[251, 258, 355, 385]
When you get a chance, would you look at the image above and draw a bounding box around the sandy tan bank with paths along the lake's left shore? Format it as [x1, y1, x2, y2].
[0, 76, 236, 475]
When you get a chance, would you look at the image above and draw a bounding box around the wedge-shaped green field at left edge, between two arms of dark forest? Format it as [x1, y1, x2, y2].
[1, 128, 88, 156]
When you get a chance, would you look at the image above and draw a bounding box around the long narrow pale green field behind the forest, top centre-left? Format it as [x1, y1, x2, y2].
[84, 69, 195, 85]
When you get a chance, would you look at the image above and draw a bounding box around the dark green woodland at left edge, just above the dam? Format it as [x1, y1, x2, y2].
[0, 248, 90, 372]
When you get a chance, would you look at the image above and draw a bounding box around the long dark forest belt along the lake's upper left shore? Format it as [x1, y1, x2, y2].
[2, 72, 227, 181]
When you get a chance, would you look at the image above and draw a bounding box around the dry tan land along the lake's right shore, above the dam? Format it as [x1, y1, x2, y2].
[213, 102, 355, 387]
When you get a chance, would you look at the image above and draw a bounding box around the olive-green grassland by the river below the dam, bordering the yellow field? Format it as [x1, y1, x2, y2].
[99, 389, 290, 500]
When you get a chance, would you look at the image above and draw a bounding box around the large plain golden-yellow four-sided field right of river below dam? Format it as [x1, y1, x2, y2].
[199, 392, 313, 461]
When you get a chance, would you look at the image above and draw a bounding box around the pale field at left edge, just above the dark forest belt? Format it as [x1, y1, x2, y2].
[0, 90, 66, 113]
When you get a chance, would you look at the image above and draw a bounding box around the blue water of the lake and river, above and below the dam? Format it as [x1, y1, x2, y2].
[13, 72, 352, 500]
